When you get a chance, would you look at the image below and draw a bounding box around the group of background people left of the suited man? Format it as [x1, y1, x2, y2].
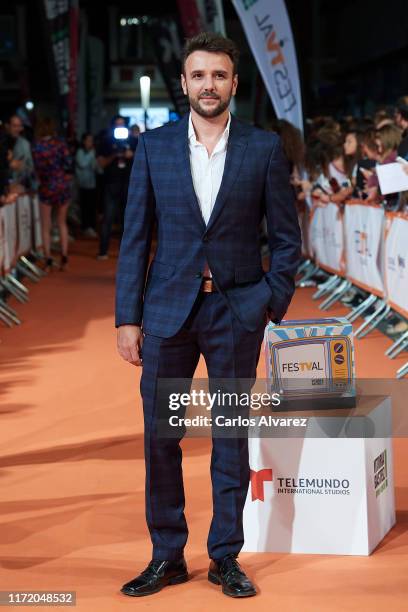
[0, 113, 139, 270]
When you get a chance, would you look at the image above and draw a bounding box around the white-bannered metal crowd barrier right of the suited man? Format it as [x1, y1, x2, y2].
[296, 200, 408, 378]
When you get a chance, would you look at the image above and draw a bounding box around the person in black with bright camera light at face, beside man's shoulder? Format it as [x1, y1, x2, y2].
[97, 115, 133, 260]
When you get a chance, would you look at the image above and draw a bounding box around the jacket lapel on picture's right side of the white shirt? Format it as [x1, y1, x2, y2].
[207, 115, 247, 231]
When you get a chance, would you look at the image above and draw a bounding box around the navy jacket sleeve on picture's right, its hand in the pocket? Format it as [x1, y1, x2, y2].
[265, 137, 301, 323]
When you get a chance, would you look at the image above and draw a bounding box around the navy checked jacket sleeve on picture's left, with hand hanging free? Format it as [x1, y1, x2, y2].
[115, 135, 155, 327]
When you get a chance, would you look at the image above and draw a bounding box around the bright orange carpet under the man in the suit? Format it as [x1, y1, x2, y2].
[0, 241, 408, 612]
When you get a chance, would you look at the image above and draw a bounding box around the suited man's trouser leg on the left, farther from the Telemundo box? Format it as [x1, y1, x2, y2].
[141, 329, 200, 561]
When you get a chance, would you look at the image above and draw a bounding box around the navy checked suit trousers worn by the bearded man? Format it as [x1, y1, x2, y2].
[141, 292, 265, 560]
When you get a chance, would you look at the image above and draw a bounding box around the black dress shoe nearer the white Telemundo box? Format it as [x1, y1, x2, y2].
[208, 555, 256, 597]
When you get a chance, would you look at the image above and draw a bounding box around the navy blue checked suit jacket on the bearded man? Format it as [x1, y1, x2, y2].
[116, 115, 300, 338]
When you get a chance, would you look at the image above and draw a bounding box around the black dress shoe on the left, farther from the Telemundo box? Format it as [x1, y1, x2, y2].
[121, 557, 188, 597]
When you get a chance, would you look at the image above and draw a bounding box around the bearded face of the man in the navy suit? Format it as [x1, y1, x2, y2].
[181, 51, 238, 117]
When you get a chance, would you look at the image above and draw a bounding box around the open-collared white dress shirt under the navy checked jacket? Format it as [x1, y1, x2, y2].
[188, 113, 231, 225]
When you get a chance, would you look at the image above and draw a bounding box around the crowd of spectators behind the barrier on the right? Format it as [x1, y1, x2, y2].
[271, 96, 408, 210]
